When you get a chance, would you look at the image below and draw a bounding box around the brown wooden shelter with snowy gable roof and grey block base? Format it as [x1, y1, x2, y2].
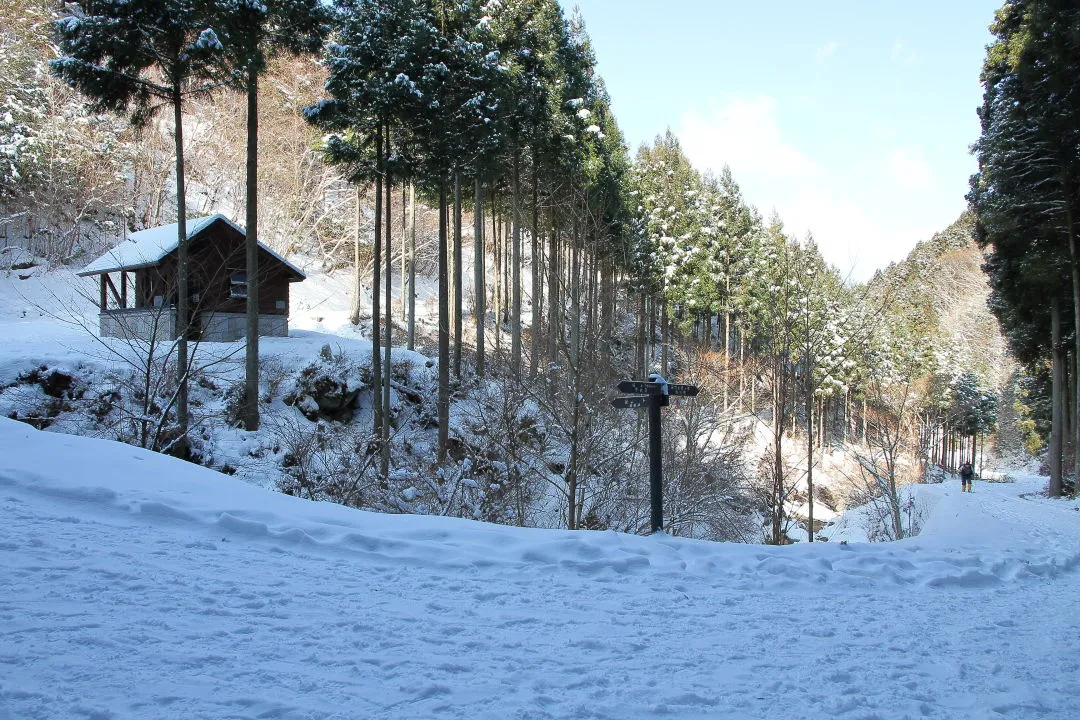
[79, 215, 305, 342]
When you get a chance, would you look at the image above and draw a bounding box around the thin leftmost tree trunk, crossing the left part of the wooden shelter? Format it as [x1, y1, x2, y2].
[173, 85, 190, 457]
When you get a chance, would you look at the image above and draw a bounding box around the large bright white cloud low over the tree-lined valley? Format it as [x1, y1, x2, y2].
[676, 96, 946, 280]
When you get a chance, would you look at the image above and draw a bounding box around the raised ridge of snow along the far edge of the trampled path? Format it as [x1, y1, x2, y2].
[0, 419, 1080, 588]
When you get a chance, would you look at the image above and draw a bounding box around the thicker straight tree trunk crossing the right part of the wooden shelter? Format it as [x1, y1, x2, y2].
[242, 70, 259, 432]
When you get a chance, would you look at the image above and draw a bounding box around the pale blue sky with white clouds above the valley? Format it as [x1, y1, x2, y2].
[564, 0, 1001, 280]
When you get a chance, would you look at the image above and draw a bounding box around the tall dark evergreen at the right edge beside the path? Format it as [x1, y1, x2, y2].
[969, 0, 1080, 494]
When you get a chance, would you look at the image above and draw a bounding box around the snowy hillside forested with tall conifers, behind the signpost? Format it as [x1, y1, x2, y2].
[0, 0, 1038, 544]
